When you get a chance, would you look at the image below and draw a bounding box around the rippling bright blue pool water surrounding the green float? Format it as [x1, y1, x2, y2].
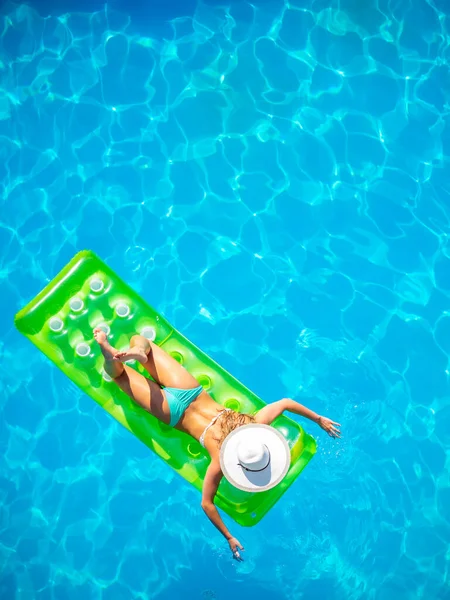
[0, 0, 450, 600]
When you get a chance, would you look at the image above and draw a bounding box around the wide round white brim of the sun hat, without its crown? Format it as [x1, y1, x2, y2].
[220, 423, 291, 492]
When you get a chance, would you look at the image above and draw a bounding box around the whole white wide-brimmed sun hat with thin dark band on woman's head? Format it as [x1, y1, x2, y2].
[220, 423, 291, 492]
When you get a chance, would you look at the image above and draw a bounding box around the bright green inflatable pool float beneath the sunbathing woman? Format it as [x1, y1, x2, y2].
[15, 251, 316, 526]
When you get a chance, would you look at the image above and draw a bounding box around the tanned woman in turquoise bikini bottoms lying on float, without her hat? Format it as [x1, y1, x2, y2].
[94, 328, 340, 560]
